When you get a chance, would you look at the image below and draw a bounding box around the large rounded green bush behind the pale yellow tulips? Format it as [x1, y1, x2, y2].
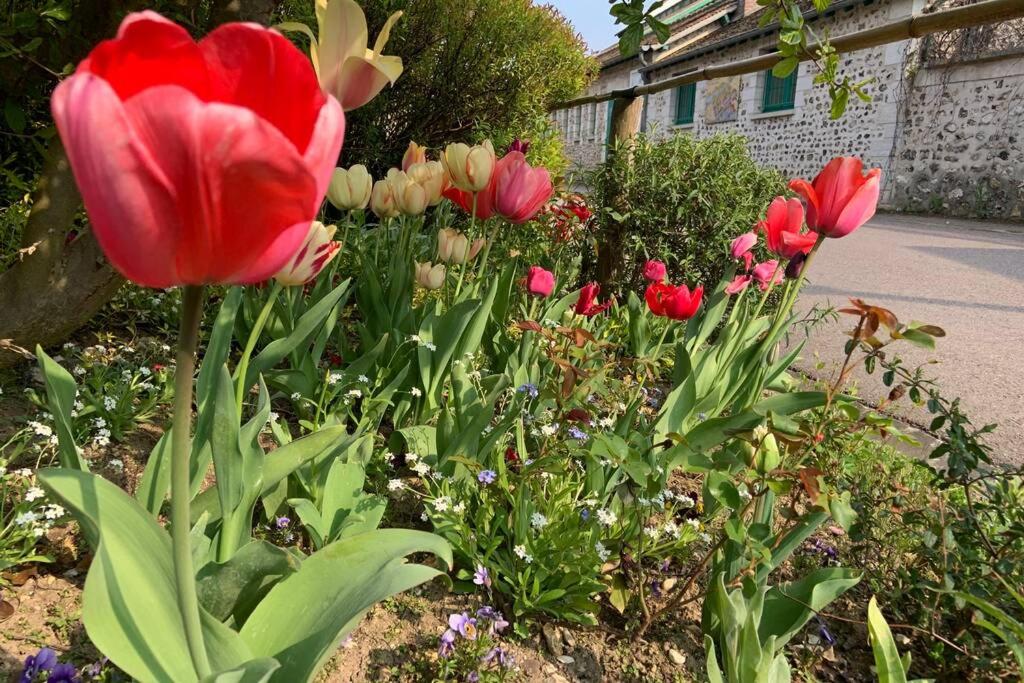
[281, 0, 596, 176]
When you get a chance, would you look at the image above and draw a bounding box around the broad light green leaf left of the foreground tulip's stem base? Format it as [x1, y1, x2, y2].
[38, 469, 252, 682]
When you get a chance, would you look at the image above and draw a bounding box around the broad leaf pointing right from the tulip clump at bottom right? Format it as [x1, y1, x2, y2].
[758, 567, 860, 648]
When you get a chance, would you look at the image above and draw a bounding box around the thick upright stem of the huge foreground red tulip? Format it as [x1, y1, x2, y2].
[171, 285, 211, 679]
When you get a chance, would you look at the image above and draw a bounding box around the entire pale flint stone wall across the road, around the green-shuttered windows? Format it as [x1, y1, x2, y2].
[560, 0, 1024, 218]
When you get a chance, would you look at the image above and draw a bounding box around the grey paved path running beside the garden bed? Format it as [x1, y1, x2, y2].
[798, 215, 1024, 465]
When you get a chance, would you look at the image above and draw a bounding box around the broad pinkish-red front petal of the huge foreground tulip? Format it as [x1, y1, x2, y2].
[117, 86, 318, 285]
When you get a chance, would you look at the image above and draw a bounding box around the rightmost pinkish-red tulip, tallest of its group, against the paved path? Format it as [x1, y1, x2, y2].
[790, 157, 882, 238]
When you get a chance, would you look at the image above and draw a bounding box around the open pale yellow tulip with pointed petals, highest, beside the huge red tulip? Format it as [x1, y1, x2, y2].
[311, 0, 402, 112]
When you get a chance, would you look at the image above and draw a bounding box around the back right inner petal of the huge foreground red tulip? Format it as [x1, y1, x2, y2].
[200, 24, 327, 154]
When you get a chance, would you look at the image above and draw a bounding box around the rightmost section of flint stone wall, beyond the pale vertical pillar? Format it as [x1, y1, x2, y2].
[888, 52, 1024, 219]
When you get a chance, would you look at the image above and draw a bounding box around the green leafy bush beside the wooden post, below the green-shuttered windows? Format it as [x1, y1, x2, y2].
[587, 134, 785, 292]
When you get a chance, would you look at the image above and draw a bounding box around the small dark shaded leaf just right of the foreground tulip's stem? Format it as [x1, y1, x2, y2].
[196, 541, 300, 625]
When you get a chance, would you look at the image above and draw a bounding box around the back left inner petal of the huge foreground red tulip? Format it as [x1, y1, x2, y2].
[78, 10, 211, 99]
